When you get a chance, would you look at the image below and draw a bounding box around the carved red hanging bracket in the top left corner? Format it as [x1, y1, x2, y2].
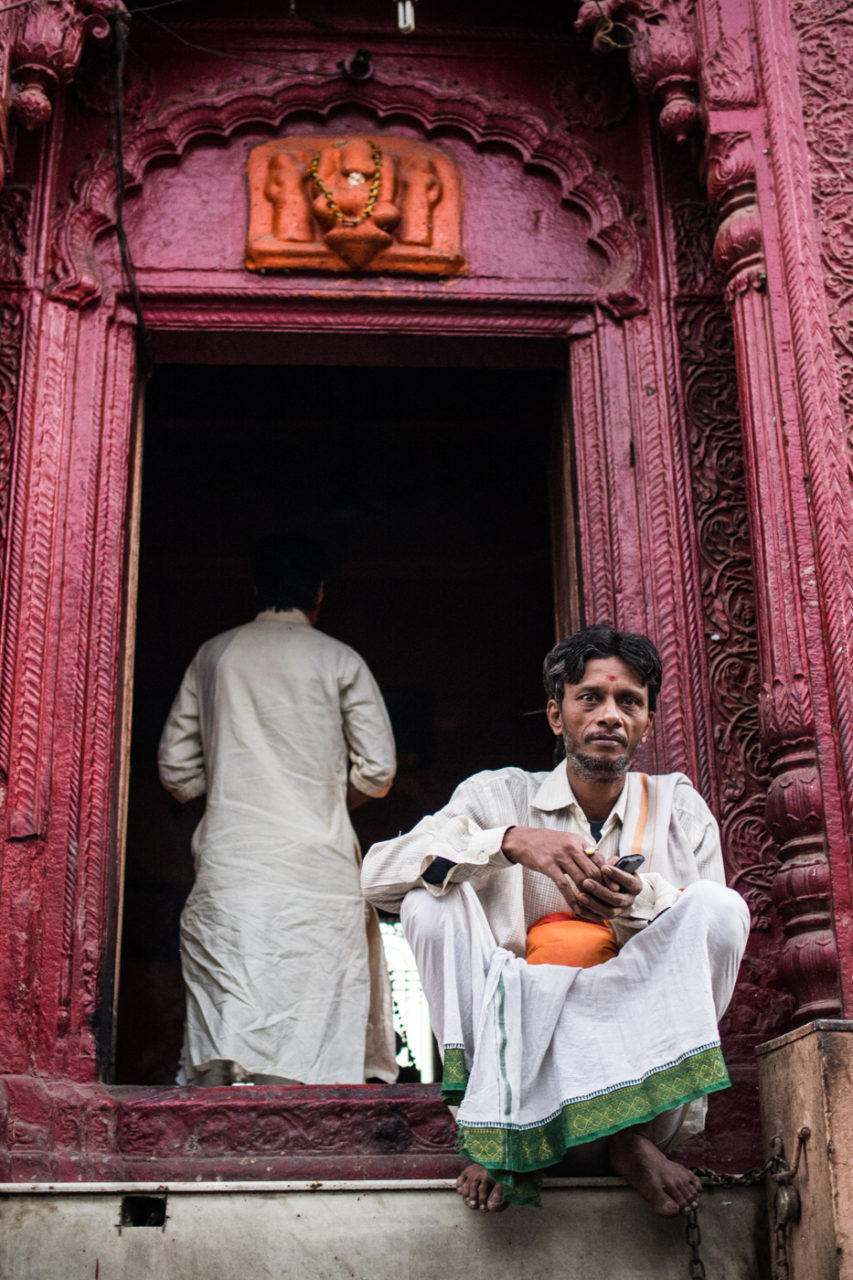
[12, 0, 116, 129]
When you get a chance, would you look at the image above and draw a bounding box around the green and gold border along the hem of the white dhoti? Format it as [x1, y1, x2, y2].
[455, 1044, 730, 1204]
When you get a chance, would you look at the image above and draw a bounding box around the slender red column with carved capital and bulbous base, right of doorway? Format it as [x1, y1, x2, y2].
[707, 133, 841, 1021]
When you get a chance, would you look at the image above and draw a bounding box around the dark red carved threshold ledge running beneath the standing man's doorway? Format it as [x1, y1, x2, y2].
[0, 1076, 460, 1181]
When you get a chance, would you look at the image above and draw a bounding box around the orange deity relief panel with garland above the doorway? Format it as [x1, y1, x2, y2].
[246, 136, 465, 275]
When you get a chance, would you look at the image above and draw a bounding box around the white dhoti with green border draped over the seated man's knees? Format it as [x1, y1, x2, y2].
[401, 881, 749, 1202]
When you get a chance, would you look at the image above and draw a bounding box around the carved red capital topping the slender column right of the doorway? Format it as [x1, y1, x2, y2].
[706, 133, 767, 301]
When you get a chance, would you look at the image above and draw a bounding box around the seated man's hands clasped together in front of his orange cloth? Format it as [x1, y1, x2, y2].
[501, 827, 643, 920]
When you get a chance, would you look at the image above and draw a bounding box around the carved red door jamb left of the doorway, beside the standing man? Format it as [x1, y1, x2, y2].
[0, 293, 134, 1079]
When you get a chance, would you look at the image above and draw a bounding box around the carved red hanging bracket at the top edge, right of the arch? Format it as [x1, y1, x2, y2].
[575, 0, 699, 142]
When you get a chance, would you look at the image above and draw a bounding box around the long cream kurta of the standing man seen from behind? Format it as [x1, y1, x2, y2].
[159, 609, 396, 1084]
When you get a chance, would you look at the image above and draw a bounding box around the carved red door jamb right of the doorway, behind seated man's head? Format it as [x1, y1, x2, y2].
[571, 308, 716, 799]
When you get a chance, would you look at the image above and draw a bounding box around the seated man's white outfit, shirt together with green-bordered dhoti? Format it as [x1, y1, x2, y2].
[362, 763, 749, 1202]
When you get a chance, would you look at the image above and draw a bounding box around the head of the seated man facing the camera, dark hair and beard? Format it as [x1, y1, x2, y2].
[543, 623, 661, 782]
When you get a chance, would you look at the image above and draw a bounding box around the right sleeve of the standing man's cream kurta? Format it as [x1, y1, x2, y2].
[339, 655, 397, 797]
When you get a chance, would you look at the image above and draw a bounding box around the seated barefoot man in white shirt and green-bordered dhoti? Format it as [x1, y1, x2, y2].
[362, 626, 749, 1216]
